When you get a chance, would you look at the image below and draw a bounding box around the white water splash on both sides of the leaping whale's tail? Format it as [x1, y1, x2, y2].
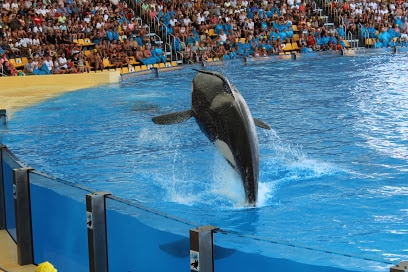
[156, 124, 340, 210]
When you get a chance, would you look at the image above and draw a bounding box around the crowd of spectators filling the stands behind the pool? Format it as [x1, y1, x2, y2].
[0, 0, 408, 75]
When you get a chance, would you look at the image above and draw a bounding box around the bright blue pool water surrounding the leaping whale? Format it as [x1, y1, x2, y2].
[0, 55, 408, 271]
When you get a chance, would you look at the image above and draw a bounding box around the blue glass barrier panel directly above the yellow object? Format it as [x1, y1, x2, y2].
[29, 172, 90, 271]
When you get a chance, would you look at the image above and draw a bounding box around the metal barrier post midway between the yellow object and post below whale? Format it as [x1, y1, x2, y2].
[86, 192, 110, 272]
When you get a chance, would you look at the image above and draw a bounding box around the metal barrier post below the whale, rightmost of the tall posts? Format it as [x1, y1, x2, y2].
[190, 226, 218, 272]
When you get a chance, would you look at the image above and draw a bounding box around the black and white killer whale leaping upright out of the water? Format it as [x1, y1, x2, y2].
[152, 70, 271, 206]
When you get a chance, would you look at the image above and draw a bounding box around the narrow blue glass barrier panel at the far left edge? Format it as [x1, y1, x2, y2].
[2, 149, 25, 241]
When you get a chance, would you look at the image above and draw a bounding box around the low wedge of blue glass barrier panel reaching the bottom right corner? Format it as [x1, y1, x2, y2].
[214, 231, 389, 272]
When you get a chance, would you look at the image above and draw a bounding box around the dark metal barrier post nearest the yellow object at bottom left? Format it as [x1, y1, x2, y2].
[13, 168, 34, 265]
